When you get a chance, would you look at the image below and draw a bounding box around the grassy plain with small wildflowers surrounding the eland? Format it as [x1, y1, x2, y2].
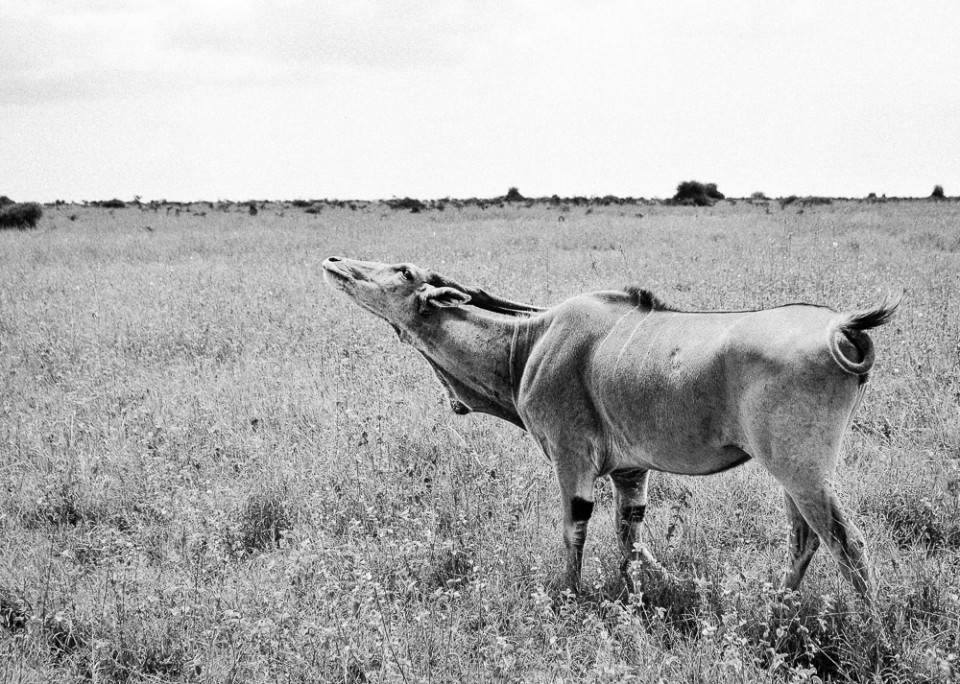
[0, 202, 960, 683]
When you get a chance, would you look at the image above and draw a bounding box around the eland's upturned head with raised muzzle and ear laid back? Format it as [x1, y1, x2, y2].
[323, 257, 471, 337]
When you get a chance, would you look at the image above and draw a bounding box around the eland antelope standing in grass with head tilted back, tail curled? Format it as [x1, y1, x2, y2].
[323, 257, 899, 604]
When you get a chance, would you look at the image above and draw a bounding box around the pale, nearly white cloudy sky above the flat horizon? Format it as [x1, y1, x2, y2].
[0, 0, 960, 201]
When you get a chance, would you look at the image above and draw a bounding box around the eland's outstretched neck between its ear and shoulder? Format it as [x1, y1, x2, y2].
[414, 309, 540, 428]
